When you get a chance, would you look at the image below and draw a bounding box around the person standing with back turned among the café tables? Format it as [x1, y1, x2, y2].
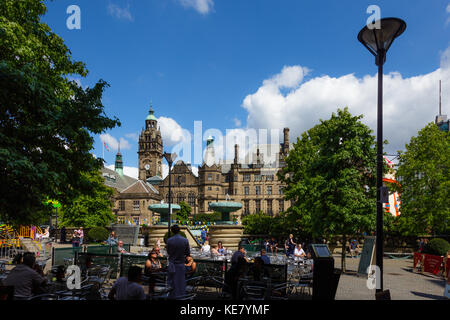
[166, 224, 191, 299]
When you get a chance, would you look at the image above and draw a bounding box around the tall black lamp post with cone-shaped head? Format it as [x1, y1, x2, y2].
[358, 18, 406, 292]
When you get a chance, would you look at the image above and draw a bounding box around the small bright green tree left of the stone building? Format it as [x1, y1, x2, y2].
[61, 171, 114, 228]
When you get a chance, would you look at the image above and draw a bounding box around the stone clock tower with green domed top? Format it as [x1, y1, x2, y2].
[138, 104, 163, 180]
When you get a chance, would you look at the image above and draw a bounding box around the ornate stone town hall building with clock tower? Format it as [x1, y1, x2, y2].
[103, 107, 291, 224]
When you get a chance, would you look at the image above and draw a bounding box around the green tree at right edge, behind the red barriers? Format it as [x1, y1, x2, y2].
[397, 123, 450, 235]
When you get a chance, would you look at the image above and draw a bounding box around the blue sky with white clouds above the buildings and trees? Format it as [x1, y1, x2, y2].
[43, 0, 450, 178]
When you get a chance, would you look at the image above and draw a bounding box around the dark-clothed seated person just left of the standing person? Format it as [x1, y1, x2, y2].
[108, 266, 147, 300]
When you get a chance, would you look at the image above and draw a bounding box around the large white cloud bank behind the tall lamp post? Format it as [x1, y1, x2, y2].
[242, 48, 450, 153]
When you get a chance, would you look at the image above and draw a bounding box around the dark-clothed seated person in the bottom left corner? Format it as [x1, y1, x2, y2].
[2, 252, 47, 299]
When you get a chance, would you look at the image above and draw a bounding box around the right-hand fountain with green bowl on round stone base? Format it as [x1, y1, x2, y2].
[209, 194, 244, 250]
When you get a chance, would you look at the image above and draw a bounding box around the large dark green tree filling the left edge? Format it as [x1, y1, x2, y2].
[0, 0, 120, 224]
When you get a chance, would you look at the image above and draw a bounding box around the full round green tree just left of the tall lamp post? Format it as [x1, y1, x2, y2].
[279, 108, 376, 271]
